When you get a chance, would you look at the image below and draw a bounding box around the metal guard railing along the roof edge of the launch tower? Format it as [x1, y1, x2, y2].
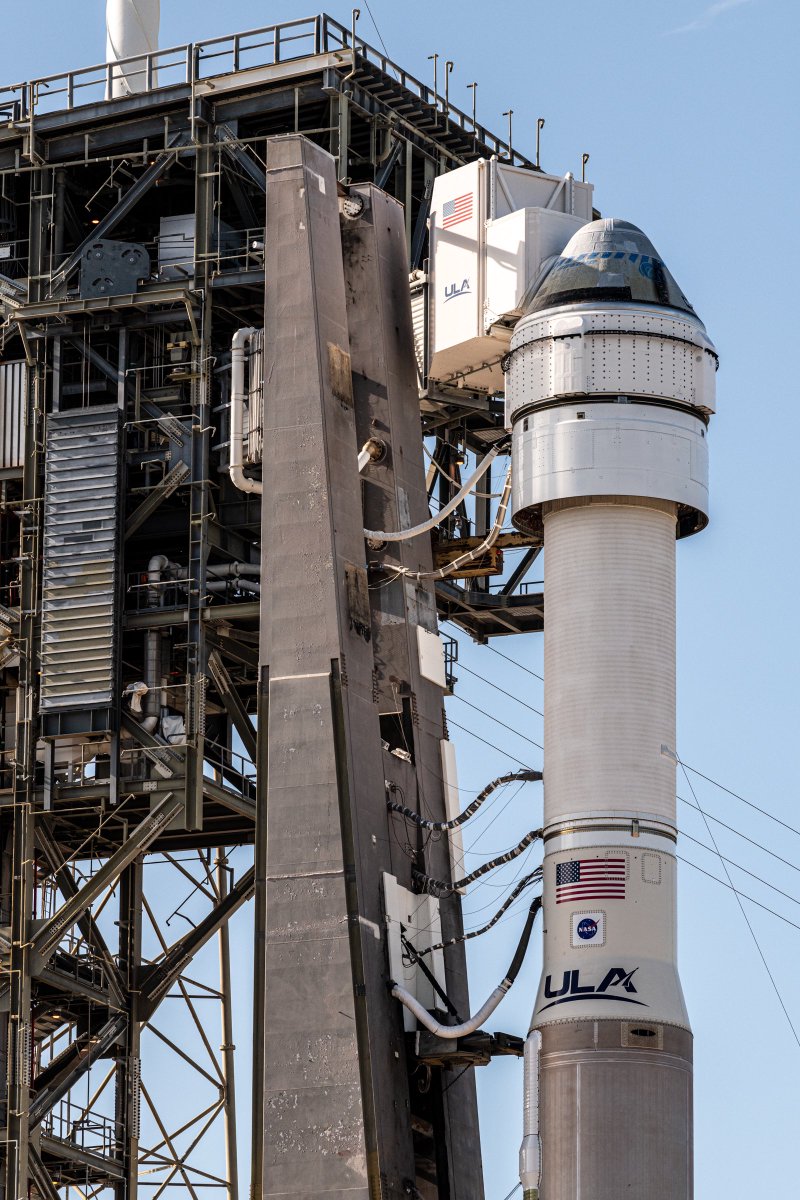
[0, 13, 530, 166]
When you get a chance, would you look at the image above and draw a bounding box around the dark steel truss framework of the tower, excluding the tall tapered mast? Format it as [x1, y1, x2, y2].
[0, 17, 542, 1200]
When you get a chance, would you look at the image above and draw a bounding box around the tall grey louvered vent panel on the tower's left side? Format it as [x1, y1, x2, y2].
[40, 408, 120, 713]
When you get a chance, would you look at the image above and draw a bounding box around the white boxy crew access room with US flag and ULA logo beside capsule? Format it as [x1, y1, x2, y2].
[427, 160, 593, 392]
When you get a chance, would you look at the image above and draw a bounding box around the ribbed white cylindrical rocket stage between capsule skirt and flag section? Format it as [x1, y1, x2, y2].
[545, 500, 675, 827]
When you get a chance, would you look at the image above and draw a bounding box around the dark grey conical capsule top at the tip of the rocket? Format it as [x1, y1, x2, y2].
[527, 217, 694, 314]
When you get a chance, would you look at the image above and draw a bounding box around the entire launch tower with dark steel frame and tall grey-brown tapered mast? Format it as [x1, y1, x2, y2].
[0, 16, 542, 1200]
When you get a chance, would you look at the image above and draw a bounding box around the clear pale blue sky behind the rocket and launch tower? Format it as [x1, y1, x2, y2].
[7, 0, 800, 1200]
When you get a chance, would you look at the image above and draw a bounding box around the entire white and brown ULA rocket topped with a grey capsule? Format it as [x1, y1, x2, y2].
[506, 220, 717, 1200]
